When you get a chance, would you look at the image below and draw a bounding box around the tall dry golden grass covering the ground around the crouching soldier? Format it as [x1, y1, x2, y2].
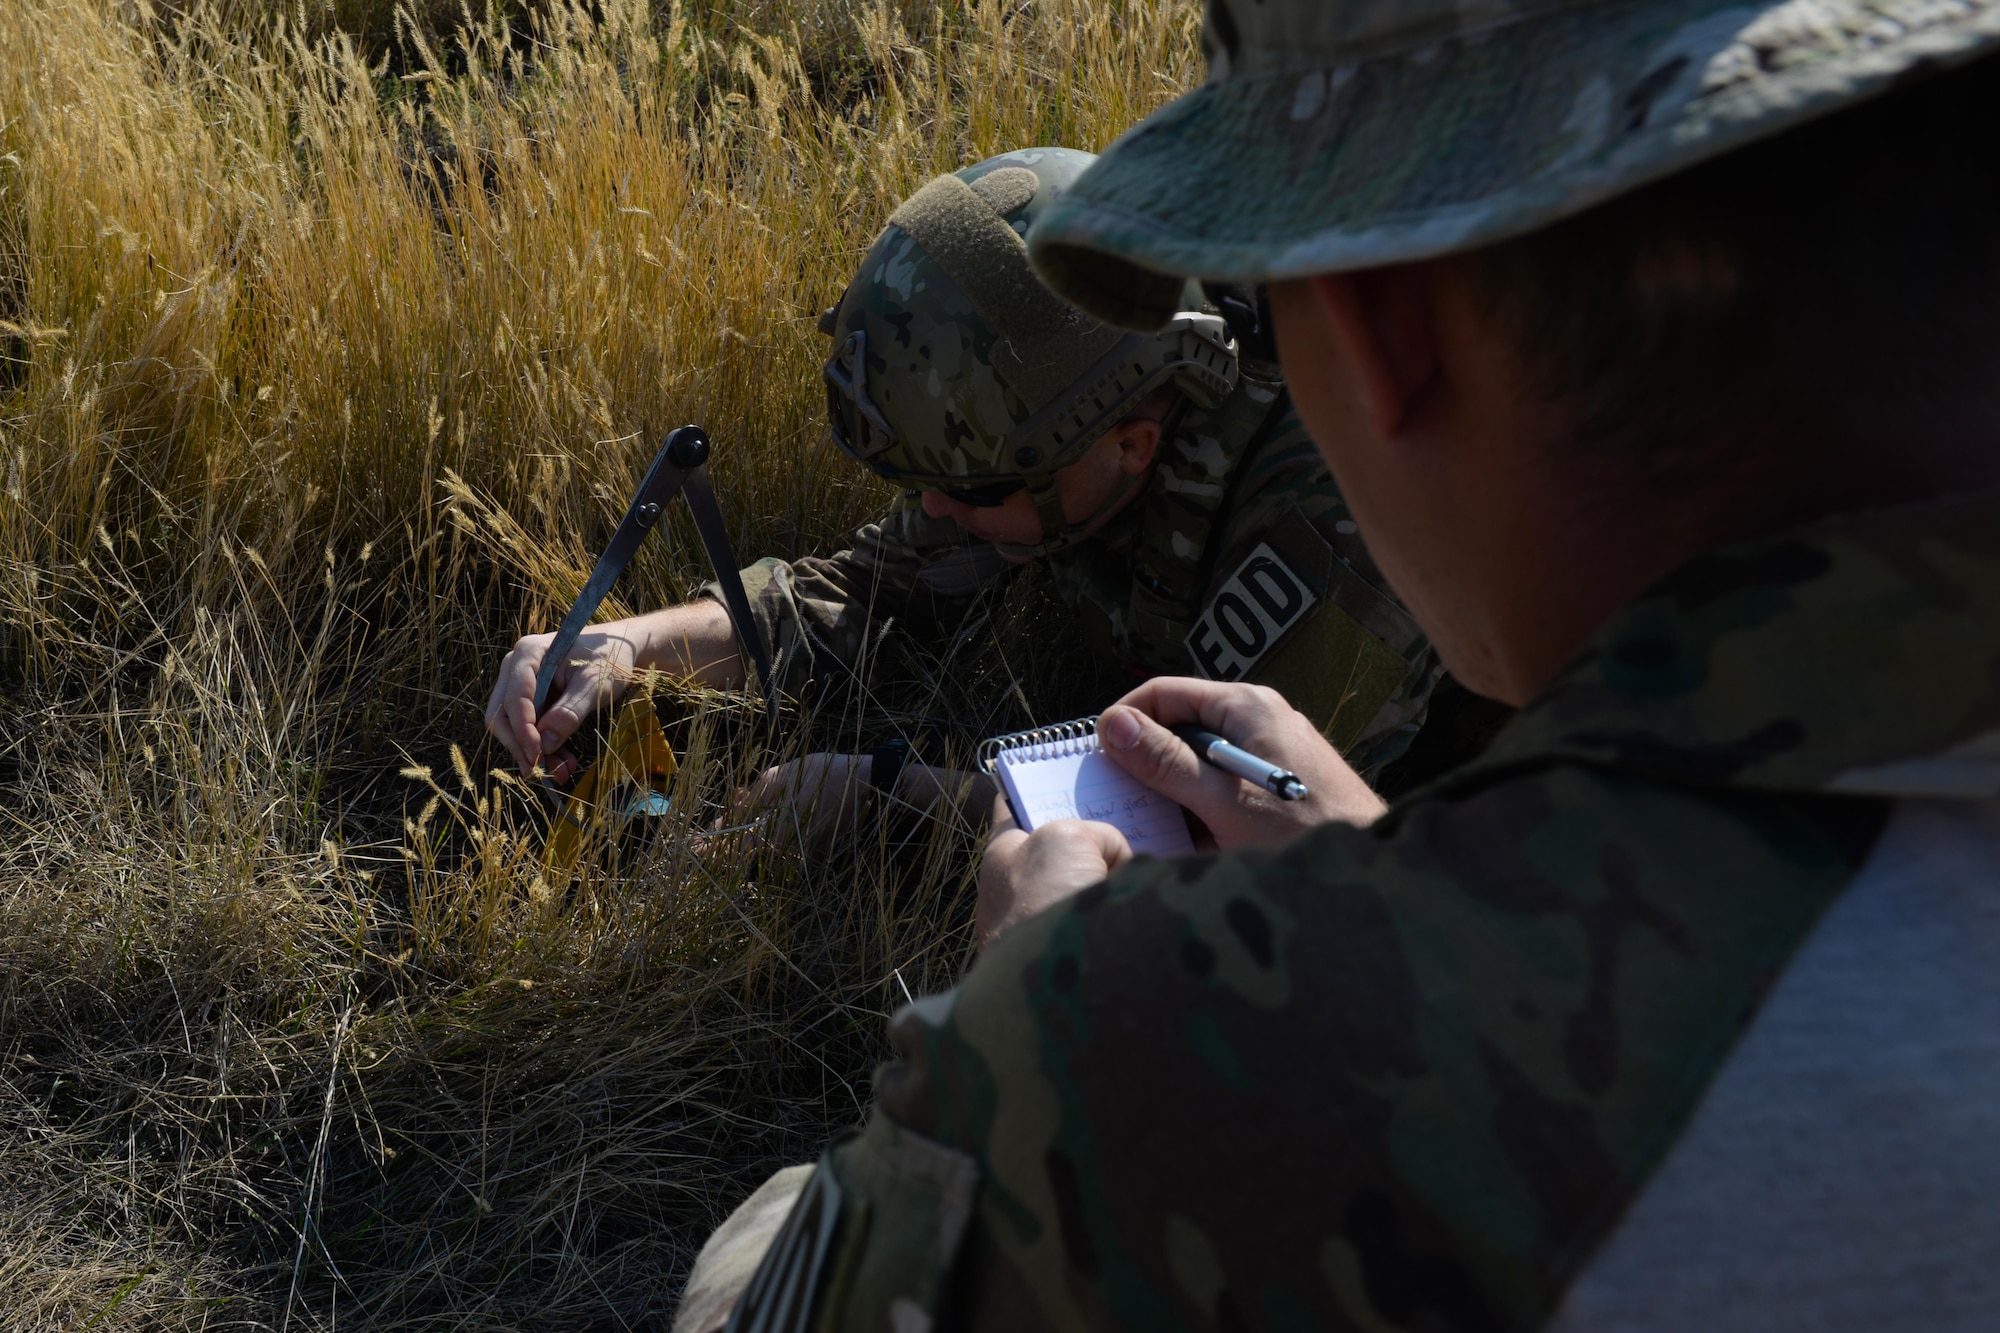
[0, 0, 1194, 1329]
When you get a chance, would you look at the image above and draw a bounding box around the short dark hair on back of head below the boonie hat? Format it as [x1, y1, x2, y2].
[1468, 58, 2000, 480]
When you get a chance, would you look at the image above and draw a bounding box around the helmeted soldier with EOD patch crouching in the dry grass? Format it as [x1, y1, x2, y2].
[488, 148, 1488, 801]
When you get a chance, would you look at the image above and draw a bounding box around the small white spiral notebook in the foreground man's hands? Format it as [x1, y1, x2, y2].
[980, 717, 1194, 857]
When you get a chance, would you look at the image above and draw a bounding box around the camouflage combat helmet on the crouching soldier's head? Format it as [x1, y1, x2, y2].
[820, 148, 1236, 554]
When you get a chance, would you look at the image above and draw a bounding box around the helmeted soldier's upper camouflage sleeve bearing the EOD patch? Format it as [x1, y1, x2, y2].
[1188, 410, 1470, 779]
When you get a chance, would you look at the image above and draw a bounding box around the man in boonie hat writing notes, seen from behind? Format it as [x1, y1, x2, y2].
[680, 0, 2000, 1333]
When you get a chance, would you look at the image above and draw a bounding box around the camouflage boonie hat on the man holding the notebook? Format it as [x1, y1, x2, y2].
[1028, 0, 2000, 328]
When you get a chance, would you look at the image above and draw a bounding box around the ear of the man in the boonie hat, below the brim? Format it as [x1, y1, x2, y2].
[1308, 264, 1438, 438]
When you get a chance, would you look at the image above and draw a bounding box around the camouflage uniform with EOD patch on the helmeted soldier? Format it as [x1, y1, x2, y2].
[744, 366, 1438, 773]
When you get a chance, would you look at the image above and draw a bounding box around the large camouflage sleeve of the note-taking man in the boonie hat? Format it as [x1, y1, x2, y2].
[764, 769, 1866, 1331]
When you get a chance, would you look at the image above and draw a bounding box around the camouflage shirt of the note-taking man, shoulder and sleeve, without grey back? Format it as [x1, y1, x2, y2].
[700, 496, 2000, 1331]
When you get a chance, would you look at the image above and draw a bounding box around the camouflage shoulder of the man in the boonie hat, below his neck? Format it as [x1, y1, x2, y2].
[1482, 492, 2000, 799]
